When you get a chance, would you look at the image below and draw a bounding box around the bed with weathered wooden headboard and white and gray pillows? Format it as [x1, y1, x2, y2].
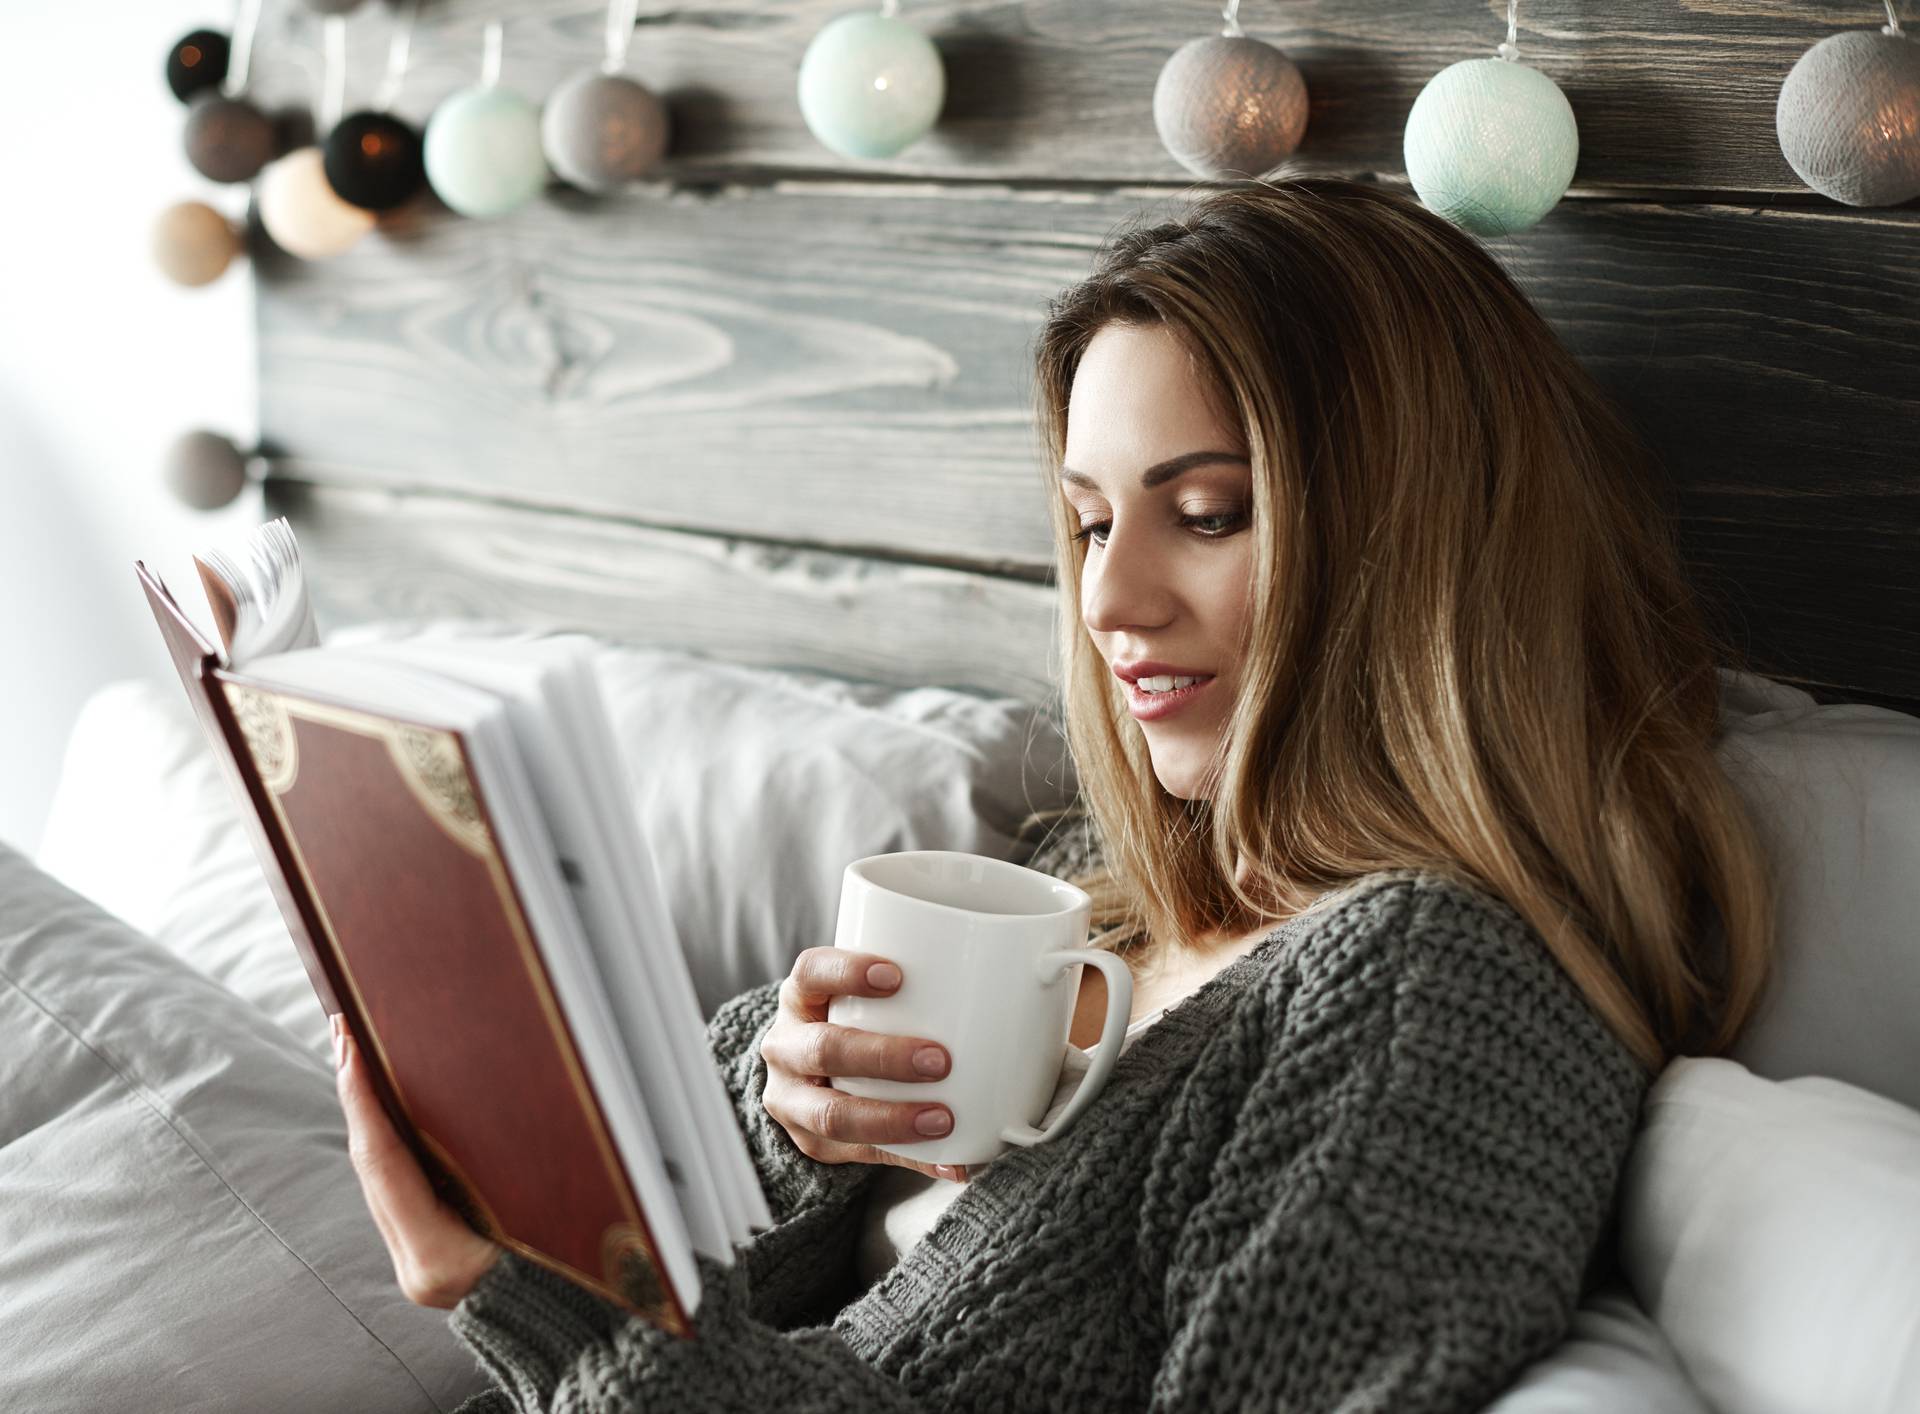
[0, 0, 1920, 1414]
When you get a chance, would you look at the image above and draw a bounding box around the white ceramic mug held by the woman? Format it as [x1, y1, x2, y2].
[828, 849, 1133, 1164]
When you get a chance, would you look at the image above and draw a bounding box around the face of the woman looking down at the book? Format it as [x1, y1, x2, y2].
[1060, 325, 1254, 799]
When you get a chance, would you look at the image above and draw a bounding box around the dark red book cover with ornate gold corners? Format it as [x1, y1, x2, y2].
[138, 565, 691, 1335]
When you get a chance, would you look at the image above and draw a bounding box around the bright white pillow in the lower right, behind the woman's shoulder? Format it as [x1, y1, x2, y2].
[1619, 1057, 1920, 1414]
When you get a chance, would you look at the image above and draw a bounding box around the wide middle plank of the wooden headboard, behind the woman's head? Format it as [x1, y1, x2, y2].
[255, 183, 1920, 695]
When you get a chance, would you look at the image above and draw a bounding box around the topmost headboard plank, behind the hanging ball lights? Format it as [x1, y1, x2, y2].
[240, 0, 1884, 200]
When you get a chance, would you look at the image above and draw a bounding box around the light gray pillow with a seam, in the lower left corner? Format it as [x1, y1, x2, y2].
[0, 843, 490, 1414]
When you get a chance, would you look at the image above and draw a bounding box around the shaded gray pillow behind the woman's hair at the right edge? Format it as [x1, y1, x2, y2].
[1718, 672, 1920, 1109]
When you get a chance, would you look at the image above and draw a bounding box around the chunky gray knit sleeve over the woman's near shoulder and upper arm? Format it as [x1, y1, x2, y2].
[1148, 893, 1647, 1414]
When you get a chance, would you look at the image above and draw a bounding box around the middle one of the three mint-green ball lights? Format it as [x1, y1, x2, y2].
[799, 12, 947, 158]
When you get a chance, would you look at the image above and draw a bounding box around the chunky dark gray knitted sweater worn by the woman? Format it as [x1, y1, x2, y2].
[449, 870, 1649, 1414]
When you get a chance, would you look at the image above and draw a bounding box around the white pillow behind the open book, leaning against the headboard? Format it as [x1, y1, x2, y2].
[38, 621, 1073, 1055]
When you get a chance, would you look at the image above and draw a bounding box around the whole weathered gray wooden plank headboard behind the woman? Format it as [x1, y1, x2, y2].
[252, 0, 1920, 713]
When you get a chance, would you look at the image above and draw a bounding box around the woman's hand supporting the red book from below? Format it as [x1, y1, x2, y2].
[334, 1014, 505, 1310]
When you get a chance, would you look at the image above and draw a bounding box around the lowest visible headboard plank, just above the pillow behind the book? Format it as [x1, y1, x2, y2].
[267, 480, 1054, 701]
